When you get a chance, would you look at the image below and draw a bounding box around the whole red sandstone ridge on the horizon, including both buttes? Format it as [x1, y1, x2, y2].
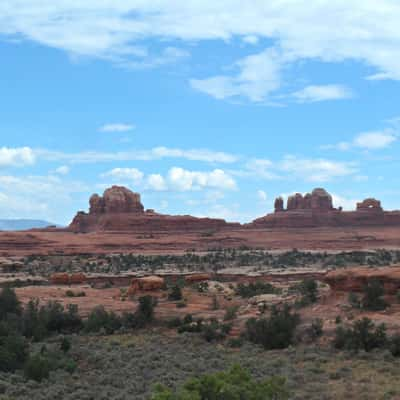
[67, 186, 400, 233]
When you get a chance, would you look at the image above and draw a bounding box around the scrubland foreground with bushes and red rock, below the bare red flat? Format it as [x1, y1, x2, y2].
[0, 250, 400, 400]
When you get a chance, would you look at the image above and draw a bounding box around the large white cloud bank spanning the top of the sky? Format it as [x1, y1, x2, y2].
[0, 0, 400, 101]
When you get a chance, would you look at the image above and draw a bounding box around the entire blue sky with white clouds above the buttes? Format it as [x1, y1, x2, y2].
[0, 0, 400, 224]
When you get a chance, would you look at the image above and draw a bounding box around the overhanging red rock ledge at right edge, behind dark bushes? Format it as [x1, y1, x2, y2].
[323, 267, 400, 294]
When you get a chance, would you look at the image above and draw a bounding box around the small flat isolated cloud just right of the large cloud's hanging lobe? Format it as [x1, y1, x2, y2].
[293, 85, 353, 103]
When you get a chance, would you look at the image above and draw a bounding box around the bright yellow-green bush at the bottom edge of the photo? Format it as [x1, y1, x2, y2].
[151, 366, 289, 400]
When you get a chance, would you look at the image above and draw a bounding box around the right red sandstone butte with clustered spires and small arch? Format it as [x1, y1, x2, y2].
[250, 189, 400, 228]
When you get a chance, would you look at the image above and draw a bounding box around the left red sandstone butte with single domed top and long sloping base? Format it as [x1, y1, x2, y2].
[68, 186, 240, 233]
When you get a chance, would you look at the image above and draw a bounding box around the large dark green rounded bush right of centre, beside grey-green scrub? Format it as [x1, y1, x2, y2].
[245, 305, 300, 350]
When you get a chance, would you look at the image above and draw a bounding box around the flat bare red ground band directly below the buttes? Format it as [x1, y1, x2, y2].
[0, 226, 400, 256]
